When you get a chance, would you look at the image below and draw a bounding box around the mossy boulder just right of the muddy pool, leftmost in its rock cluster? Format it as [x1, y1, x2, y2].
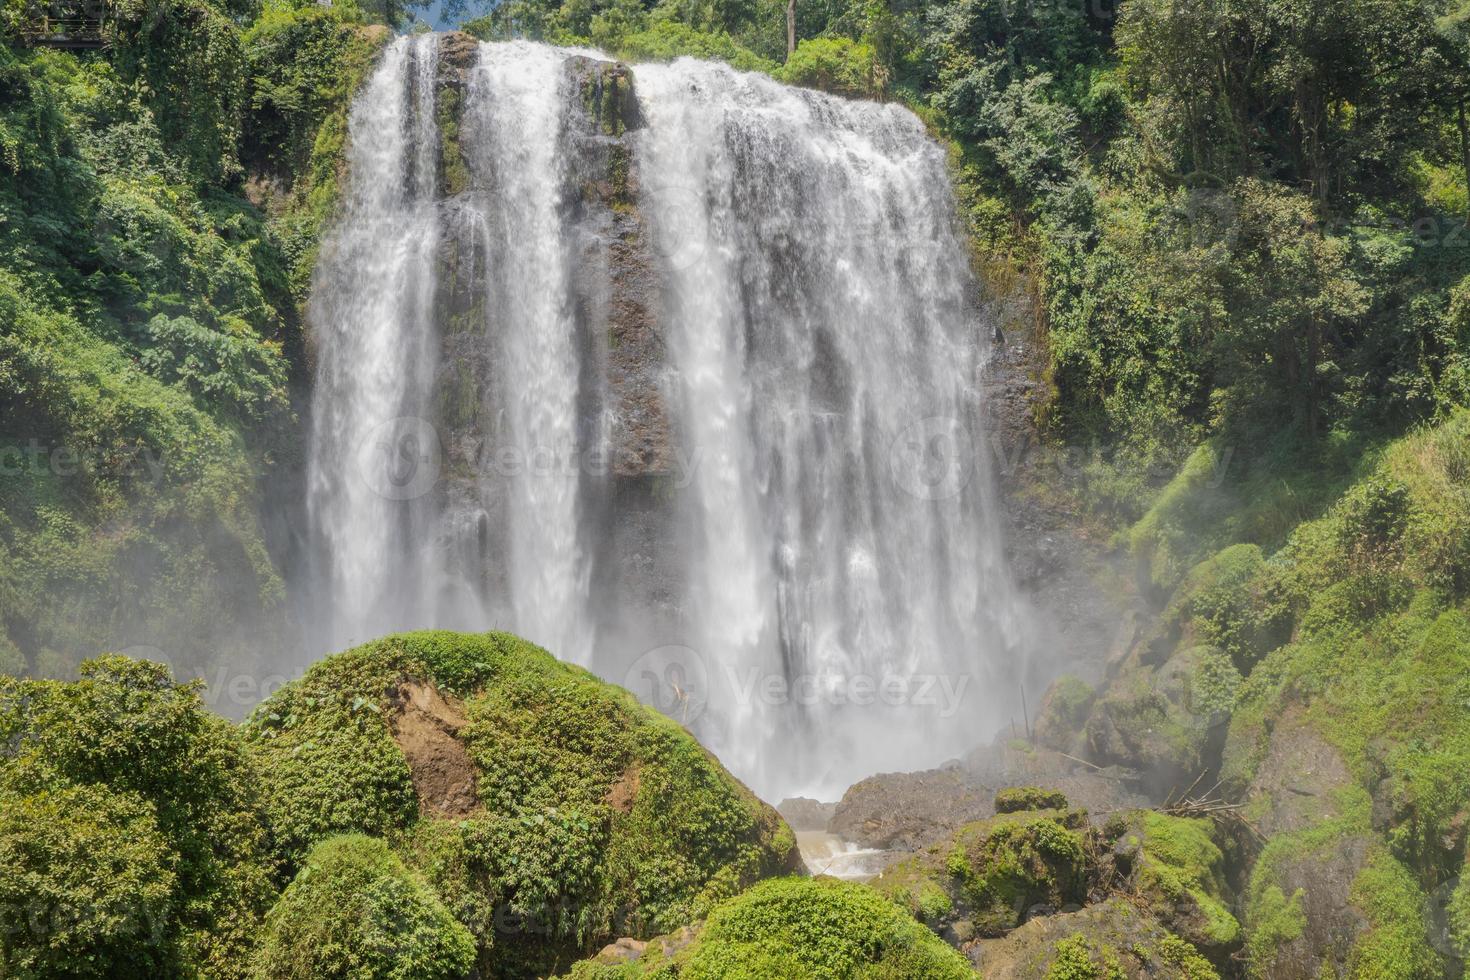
[873, 799, 1091, 945]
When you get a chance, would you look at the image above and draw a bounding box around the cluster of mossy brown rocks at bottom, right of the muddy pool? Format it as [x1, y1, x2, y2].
[873, 788, 1241, 977]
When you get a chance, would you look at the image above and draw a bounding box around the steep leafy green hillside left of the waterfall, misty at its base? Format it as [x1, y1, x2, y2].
[0, 0, 384, 674]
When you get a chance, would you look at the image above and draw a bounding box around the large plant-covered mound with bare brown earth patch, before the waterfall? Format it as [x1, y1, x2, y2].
[245, 632, 800, 976]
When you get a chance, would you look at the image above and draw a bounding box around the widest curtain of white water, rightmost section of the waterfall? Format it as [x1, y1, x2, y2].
[637, 60, 1019, 792]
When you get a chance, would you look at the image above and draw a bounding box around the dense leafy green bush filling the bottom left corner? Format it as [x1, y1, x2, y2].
[0, 655, 275, 979]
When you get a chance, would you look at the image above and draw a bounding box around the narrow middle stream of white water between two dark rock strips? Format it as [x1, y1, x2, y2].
[466, 43, 592, 664]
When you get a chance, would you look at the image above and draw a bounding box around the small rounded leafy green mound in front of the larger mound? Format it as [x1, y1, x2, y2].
[250, 835, 475, 980]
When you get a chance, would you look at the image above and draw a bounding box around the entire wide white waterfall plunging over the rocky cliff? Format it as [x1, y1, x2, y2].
[309, 35, 1026, 796]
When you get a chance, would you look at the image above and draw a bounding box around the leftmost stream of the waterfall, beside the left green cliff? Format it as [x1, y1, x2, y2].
[307, 37, 440, 646]
